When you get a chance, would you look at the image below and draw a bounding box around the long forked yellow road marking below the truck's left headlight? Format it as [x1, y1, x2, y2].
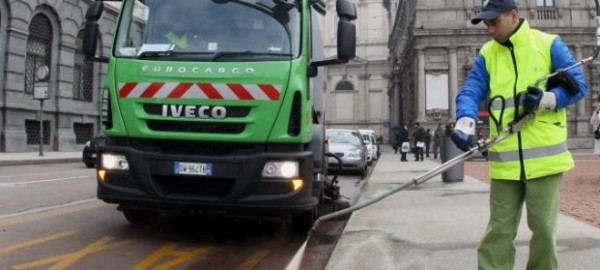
[13, 236, 136, 270]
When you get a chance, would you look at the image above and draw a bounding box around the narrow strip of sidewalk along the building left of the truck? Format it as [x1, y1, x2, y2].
[0, 151, 83, 166]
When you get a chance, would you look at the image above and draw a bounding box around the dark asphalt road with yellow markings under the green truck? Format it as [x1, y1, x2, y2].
[0, 163, 365, 270]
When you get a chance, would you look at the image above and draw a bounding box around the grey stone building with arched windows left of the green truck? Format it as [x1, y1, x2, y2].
[0, 0, 116, 152]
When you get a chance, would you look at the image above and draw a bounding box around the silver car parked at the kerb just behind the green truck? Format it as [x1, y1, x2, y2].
[325, 129, 368, 178]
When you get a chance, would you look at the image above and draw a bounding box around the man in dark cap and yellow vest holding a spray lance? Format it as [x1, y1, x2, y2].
[451, 0, 587, 270]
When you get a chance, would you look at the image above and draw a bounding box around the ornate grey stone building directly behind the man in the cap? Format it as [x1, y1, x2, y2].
[389, 0, 600, 148]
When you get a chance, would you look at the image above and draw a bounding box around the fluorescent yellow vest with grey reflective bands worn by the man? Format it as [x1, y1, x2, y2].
[481, 21, 574, 180]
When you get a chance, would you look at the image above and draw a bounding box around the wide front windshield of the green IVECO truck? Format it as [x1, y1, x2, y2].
[114, 0, 300, 61]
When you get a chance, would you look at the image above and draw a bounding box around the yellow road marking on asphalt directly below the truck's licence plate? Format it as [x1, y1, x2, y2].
[132, 243, 213, 270]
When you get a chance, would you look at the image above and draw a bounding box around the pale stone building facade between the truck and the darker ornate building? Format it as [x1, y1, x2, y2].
[322, 0, 398, 140]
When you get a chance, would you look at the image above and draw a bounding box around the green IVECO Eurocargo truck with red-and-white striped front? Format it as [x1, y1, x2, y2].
[82, 0, 357, 231]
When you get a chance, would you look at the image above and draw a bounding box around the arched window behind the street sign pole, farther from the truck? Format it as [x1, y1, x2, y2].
[25, 14, 52, 94]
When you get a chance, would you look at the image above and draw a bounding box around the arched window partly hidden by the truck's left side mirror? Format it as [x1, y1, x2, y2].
[73, 30, 94, 101]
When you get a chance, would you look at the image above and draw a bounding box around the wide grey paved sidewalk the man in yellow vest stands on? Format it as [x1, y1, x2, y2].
[326, 147, 600, 270]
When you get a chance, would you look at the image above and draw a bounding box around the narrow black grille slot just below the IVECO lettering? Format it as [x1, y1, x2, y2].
[146, 120, 246, 134]
